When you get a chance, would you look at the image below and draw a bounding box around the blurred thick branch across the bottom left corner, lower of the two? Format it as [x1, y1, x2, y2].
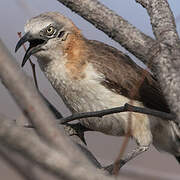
[0, 115, 112, 180]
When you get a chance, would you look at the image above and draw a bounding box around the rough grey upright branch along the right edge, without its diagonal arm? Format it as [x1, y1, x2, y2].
[137, 0, 180, 122]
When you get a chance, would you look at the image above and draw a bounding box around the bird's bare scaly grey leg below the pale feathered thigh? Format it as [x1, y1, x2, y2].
[112, 146, 149, 175]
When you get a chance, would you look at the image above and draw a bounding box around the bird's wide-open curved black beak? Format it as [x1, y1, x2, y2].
[15, 33, 47, 67]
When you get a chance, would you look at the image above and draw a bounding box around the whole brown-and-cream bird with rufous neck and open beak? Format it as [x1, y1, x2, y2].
[15, 12, 180, 166]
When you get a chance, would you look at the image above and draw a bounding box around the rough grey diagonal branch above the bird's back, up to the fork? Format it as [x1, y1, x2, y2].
[58, 0, 156, 64]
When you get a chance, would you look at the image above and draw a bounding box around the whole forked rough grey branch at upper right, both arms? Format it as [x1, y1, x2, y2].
[58, 0, 180, 122]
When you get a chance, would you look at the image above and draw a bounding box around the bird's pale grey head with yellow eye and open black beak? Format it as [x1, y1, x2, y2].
[15, 12, 79, 66]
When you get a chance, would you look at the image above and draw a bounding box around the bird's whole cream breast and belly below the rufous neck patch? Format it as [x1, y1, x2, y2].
[39, 59, 148, 135]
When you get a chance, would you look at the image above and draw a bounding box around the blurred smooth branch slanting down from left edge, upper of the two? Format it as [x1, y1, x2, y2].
[0, 41, 95, 164]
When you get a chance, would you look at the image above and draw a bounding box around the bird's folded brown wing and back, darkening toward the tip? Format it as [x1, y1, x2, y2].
[87, 40, 170, 112]
